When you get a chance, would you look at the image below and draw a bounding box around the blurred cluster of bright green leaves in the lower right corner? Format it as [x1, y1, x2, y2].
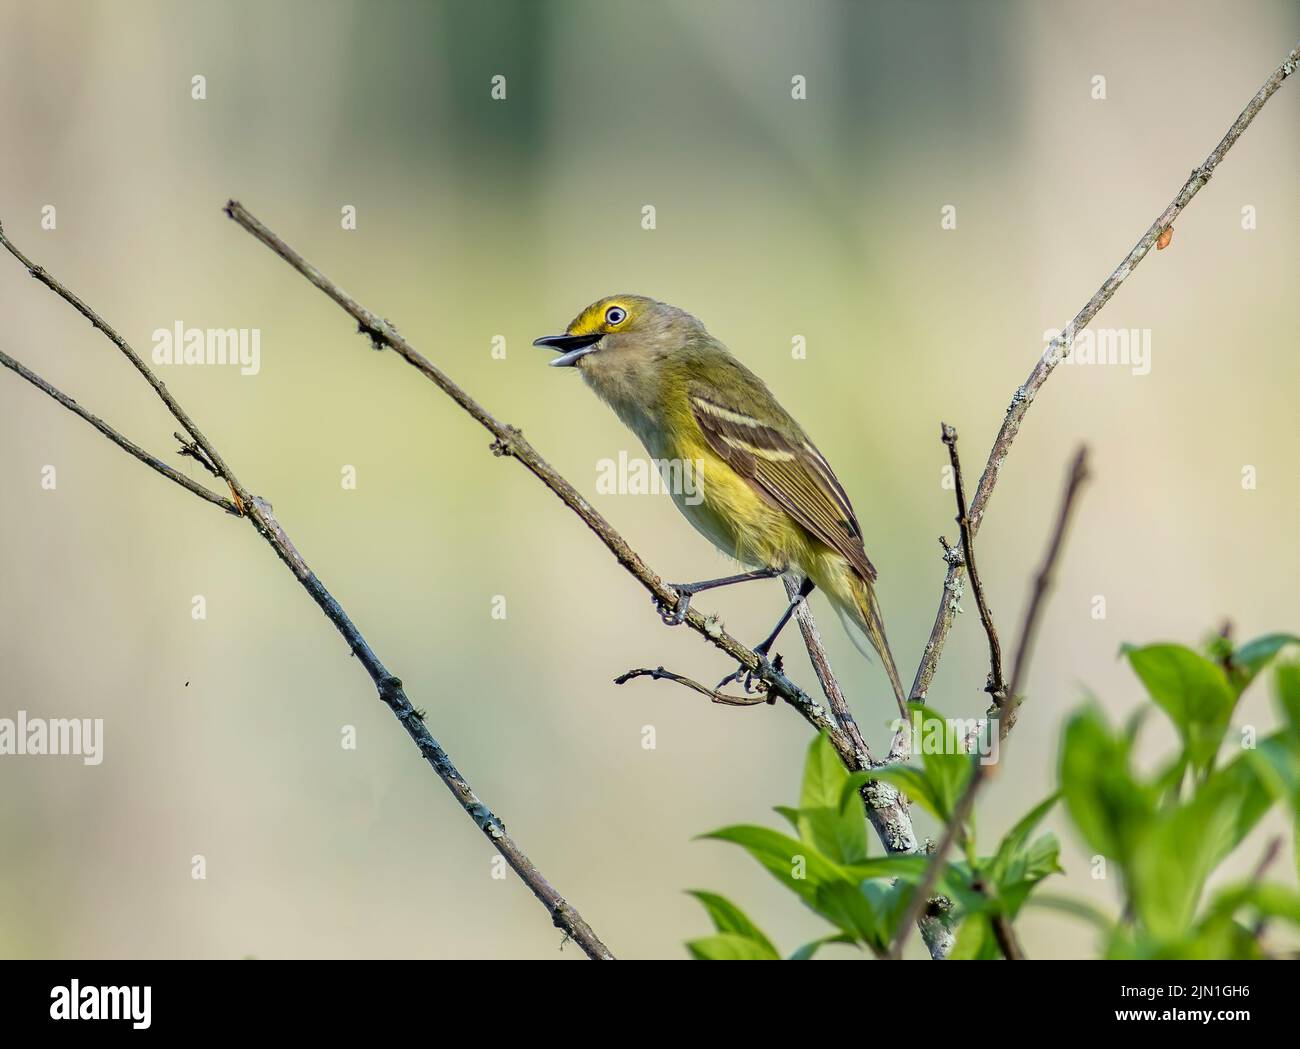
[1060, 634, 1300, 958]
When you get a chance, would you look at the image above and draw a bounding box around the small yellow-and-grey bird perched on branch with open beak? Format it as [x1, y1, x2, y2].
[533, 295, 905, 707]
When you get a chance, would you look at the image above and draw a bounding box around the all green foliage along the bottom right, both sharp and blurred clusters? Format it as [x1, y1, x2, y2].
[688, 633, 1300, 961]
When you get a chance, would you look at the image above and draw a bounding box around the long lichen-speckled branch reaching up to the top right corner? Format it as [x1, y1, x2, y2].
[911, 44, 1300, 702]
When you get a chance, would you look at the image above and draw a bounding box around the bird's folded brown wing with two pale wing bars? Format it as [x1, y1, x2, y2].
[690, 386, 876, 581]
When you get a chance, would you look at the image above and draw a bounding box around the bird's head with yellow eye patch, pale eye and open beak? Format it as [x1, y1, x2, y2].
[533, 295, 703, 370]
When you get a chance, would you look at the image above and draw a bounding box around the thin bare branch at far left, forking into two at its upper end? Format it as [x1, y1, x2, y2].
[0, 226, 614, 959]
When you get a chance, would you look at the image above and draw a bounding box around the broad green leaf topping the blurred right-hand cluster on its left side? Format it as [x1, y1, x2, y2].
[1126, 645, 1239, 771]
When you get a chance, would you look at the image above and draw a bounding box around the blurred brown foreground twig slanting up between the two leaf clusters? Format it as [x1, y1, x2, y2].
[889, 447, 1088, 958]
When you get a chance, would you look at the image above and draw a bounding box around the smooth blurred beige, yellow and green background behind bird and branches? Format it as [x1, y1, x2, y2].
[0, 0, 1300, 958]
